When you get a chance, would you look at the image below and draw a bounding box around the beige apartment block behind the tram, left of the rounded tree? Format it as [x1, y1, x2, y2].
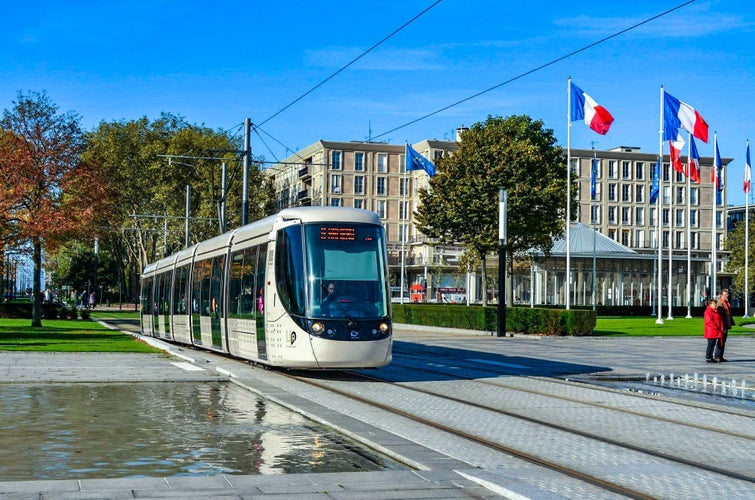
[267, 139, 462, 296]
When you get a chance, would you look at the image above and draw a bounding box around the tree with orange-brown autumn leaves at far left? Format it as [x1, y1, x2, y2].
[0, 92, 111, 326]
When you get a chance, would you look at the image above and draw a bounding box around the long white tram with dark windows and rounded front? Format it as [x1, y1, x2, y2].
[141, 207, 392, 368]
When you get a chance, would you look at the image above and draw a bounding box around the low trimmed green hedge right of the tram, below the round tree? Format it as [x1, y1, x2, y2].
[392, 304, 597, 336]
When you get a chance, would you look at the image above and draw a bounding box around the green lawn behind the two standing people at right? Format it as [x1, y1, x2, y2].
[593, 314, 755, 337]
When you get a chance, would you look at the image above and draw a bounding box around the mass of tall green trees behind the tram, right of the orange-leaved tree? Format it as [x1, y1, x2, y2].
[87, 113, 270, 299]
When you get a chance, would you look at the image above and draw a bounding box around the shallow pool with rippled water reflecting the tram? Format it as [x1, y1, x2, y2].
[0, 383, 402, 481]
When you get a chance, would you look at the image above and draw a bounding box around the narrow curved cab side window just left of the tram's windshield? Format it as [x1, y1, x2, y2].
[275, 226, 306, 315]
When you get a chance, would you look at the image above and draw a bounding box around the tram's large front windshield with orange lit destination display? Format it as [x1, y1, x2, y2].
[305, 223, 389, 319]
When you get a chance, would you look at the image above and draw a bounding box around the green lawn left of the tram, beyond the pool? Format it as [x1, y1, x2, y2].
[0, 318, 162, 353]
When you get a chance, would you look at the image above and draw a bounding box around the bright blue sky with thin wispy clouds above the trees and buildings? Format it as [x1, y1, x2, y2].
[0, 0, 755, 204]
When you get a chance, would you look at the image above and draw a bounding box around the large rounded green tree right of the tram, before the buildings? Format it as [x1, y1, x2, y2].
[416, 115, 576, 304]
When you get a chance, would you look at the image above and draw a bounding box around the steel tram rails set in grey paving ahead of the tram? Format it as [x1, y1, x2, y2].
[280, 362, 755, 498]
